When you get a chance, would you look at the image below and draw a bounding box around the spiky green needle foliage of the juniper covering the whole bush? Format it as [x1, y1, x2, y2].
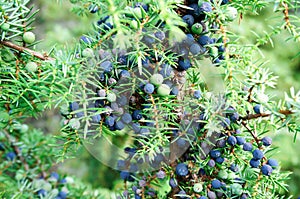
[0, 0, 300, 198]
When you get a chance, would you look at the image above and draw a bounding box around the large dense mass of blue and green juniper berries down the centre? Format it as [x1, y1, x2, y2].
[65, 0, 284, 199]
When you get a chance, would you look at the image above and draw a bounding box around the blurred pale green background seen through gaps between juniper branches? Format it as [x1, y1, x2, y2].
[28, 0, 300, 198]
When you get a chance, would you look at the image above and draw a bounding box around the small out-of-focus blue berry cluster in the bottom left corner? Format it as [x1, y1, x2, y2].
[0, 122, 73, 199]
